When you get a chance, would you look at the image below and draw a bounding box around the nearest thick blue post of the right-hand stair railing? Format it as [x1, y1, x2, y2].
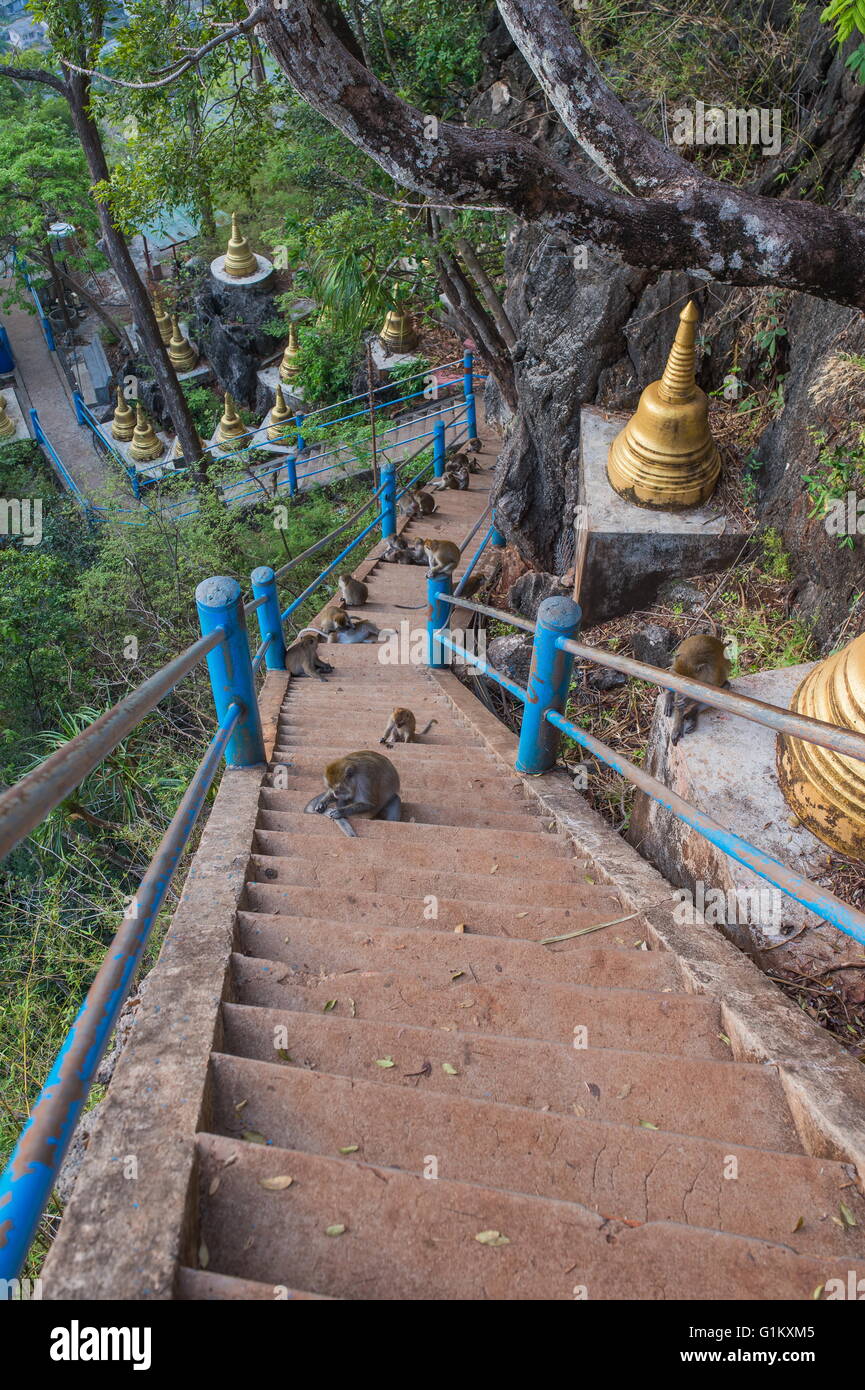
[516, 595, 583, 776]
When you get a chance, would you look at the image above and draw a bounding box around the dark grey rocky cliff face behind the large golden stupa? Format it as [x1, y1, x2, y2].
[481, 4, 865, 642]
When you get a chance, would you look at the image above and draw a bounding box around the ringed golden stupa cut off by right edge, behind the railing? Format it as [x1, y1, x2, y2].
[777, 634, 865, 859]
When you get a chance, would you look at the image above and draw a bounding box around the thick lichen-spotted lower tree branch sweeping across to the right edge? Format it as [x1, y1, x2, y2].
[261, 0, 865, 309]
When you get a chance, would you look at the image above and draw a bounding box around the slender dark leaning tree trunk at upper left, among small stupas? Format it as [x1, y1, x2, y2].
[65, 72, 206, 481]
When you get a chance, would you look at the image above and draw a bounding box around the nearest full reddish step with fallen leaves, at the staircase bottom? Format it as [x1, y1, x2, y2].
[197, 1134, 865, 1300]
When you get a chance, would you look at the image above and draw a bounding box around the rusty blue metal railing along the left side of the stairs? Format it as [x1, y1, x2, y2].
[0, 360, 481, 1279]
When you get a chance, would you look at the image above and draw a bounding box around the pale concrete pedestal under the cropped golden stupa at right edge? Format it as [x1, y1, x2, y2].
[627, 664, 836, 951]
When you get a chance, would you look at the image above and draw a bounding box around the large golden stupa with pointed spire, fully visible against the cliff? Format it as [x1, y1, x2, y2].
[606, 300, 720, 512]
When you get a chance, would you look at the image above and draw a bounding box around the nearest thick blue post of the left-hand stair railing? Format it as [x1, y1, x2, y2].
[195, 575, 264, 767]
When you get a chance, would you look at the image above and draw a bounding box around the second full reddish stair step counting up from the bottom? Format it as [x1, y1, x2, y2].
[211, 1054, 865, 1258]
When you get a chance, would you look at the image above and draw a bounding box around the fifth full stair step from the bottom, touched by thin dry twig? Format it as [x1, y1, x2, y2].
[238, 912, 680, 990]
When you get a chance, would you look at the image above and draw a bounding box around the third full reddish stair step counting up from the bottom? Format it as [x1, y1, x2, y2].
[223, 1004, 802, 1154]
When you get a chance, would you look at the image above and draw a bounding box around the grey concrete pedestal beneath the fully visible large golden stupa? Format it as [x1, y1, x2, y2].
[580, 406, 745, 627]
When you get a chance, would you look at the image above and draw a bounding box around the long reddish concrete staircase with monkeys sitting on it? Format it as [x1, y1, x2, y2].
[42, 436, 865, 1300]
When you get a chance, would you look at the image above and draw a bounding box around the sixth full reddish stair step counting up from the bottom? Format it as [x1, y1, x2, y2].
[242, 878, 623, 941]
